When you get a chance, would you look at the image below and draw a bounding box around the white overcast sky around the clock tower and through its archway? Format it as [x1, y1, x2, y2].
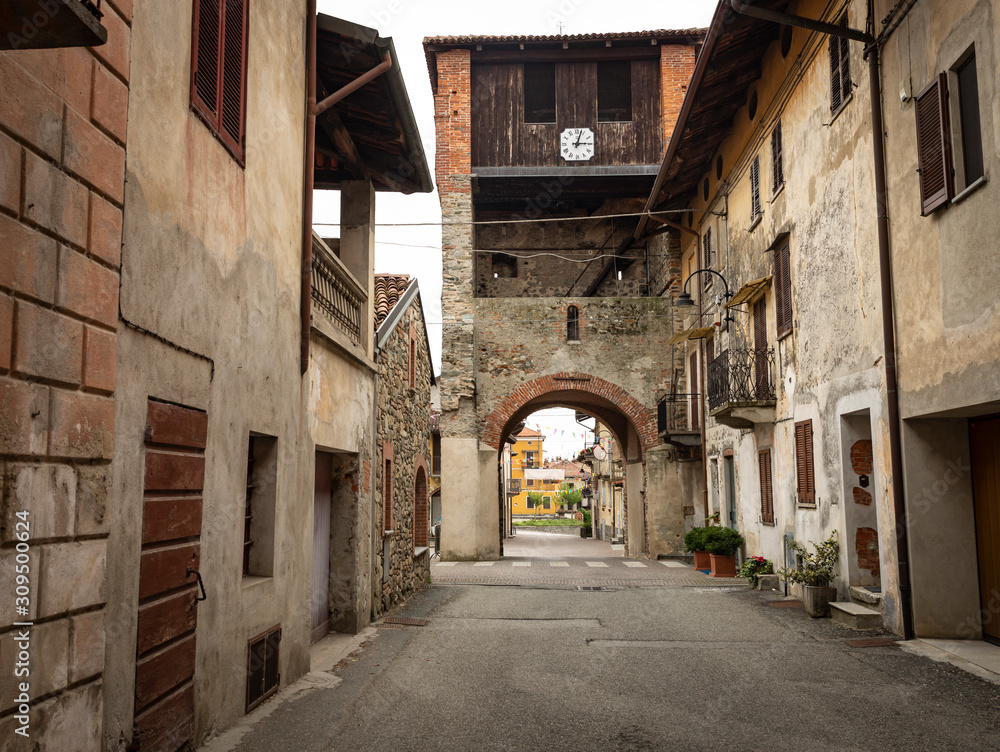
[314, 0, 715, 457]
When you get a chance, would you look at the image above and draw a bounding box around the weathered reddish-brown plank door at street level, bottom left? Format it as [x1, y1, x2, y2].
[130, 400, 208, 752]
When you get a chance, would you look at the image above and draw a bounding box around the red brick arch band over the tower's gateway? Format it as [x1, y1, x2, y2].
[483, 372, 659, 452]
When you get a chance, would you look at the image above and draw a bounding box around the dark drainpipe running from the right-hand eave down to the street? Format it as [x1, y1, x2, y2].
[729, 0, 914, 640]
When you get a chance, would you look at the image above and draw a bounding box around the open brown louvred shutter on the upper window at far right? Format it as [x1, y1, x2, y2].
[914, 73, 955, 217]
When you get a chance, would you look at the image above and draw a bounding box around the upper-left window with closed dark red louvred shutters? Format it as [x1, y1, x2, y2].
[191, 0, 249, 164]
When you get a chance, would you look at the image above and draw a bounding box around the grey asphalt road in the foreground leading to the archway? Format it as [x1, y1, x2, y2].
[227, 567, 1000, 752]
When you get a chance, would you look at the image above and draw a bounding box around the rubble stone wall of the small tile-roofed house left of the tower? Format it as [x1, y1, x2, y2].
[372, 295, 432, 618]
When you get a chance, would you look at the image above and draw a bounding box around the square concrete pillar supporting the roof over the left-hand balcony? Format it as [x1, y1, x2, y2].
[340, 180, 375, 357]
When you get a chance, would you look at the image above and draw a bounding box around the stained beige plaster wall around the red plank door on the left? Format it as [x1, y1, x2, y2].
[104, 3, 314, 749]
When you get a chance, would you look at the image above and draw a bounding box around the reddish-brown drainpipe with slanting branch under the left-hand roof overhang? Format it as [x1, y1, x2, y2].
[299, 0, 392, 373]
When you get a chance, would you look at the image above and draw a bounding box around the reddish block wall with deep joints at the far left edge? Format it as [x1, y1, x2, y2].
[0, 0, 132, 749]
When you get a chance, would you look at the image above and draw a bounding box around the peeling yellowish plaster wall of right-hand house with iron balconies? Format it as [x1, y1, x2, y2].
[682, 2, 902, 632]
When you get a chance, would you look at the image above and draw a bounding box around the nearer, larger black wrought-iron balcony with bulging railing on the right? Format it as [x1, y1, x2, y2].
[708, 347, 777, 428]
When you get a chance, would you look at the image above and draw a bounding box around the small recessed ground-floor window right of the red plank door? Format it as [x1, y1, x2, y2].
[243, 435, 278, 577]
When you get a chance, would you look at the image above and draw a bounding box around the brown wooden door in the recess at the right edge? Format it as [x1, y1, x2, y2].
[969, 418, 1000, 644]
